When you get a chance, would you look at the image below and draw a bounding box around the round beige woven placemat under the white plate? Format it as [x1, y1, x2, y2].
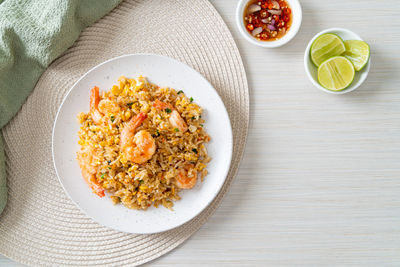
[0, 0, 249, 266]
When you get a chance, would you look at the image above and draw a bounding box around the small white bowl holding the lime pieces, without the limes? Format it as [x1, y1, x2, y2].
[304, 28, 371, 95]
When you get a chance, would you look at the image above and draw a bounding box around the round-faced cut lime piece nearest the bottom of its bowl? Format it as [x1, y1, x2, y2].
[318, 56, 355, 91]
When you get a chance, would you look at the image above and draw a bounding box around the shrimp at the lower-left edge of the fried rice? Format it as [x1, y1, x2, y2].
[78, 146, 104, 197]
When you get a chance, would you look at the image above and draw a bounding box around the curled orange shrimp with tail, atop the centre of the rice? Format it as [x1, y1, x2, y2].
[121, 113, 156, 164]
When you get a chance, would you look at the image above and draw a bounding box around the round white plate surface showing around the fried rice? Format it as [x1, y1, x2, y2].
[52, 54, 232, 234]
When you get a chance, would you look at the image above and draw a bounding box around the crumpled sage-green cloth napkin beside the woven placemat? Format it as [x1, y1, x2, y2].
[0, 0, 121, 213]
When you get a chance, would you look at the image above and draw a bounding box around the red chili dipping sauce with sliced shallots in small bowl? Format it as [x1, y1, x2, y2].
[243, 0, 292, 41]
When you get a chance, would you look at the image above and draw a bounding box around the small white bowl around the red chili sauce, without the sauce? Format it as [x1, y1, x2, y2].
[236, 0, 302, 48]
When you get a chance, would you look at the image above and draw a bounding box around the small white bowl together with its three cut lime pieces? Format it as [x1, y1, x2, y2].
[304, 28, 371, 94]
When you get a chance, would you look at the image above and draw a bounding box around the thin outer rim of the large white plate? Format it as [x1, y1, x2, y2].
[51, 53, 234, 234]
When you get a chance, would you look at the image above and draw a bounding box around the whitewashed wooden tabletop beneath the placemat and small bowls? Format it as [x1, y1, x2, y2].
[0, 0, 400, 266]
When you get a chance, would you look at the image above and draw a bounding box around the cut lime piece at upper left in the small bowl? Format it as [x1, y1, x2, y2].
[310, 33, 346, 67]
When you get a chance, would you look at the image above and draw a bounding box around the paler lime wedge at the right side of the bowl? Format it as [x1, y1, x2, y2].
[343, 40, 369, 71]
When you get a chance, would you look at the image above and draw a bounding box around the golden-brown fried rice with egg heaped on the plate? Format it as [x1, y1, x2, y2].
[78, 76, 210, 210]
